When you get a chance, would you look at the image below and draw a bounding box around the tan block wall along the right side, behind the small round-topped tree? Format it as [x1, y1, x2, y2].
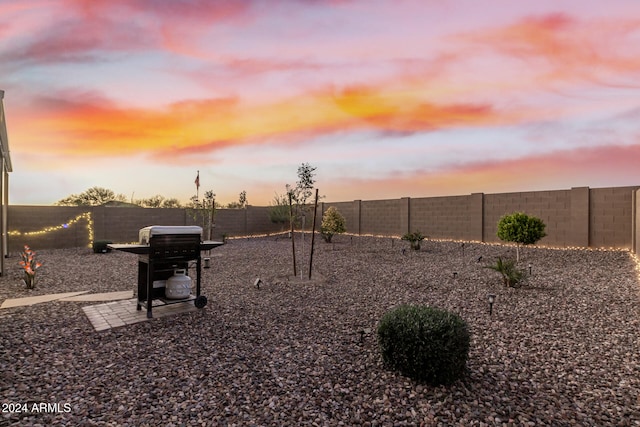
[338, 186, 640, 251]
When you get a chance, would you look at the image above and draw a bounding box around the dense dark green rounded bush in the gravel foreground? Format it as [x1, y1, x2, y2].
[378, 305, 471, 385]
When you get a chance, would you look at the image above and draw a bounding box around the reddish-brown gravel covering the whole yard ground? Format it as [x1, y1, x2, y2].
[0, 236, 640, 426]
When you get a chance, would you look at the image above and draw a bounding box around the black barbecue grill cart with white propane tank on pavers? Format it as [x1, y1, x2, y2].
[108, 225, 223, 318]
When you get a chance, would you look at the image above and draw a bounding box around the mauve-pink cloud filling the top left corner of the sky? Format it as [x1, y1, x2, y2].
[2, 0, 255, 63]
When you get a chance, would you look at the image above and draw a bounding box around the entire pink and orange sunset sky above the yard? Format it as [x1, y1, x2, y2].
[0, 0, 640, 205]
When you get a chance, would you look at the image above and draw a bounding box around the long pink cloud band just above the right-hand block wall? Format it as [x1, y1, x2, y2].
[330, 143, 640, 200]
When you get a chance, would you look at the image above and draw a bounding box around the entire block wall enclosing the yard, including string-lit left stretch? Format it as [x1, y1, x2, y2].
[7, 186, 640, 253]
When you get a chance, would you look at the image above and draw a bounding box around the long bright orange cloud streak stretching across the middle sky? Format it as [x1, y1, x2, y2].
[20, 83, 514, 160]
